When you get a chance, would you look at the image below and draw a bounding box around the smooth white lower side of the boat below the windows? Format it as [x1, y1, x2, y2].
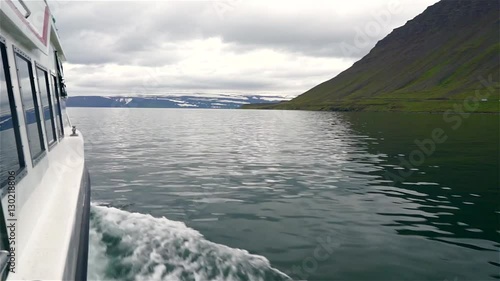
[2, 133, 88, 280]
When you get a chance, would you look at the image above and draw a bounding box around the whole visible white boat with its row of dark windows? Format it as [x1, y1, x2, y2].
[0, 0, 90, 280]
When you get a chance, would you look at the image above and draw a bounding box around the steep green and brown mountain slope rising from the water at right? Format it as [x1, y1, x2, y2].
[245, 0, 500, 112]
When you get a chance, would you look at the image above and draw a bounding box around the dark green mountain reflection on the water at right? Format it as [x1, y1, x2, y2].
[344, 113, 500, 278]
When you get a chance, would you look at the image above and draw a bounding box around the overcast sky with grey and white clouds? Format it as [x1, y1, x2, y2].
[49, 0, 438, 97]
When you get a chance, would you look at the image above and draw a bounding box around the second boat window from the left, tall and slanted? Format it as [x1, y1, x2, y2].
[15, 49, 45, 161]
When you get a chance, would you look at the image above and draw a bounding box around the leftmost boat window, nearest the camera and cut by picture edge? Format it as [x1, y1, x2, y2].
[0, 40, 25, 187]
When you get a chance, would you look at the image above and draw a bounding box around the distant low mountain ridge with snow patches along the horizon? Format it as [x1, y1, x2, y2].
[66, 95, 290, 109]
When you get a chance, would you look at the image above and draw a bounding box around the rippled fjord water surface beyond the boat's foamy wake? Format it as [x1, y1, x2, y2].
[71, 109, 500, 280]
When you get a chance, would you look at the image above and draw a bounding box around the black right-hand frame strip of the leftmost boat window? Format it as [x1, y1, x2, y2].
[0, 36, 27, 189]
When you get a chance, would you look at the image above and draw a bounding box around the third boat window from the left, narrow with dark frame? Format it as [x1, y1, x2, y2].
[36, 67, 57, 145]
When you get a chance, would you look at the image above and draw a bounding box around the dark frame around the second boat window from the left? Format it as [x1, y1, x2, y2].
[12, 45, 47, 164]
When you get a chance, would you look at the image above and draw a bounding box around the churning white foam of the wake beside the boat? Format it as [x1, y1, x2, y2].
[88, 205, 291, 281]
